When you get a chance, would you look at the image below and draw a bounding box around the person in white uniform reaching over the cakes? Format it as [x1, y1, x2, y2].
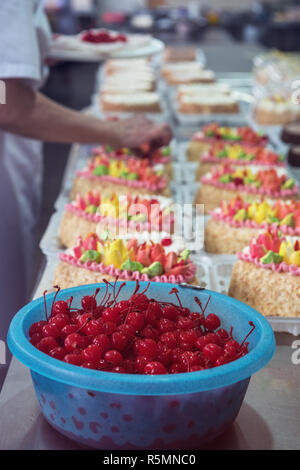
[0, 0, 171, 356]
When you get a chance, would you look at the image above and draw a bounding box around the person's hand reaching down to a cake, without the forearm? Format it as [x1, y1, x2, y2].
[111, 115, 172, 149]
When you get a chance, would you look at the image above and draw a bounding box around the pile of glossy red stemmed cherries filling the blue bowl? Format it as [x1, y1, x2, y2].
[29, 281, 255, 374]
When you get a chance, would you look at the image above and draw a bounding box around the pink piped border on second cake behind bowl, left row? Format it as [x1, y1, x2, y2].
[65, 203, 174, 232]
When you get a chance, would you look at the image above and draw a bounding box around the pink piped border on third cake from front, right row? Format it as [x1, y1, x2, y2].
[201, 176, 299, 198]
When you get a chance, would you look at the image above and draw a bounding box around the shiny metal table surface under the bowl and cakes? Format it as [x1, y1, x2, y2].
[0, 48, 300, 450]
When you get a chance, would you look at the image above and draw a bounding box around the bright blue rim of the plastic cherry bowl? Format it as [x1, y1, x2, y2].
[7, 281, 275, 395]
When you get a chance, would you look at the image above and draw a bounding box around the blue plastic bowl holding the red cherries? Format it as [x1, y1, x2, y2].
[8, 282, 275, 450]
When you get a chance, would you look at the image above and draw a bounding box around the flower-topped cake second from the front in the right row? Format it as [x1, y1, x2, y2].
[204, 196, 300, 254]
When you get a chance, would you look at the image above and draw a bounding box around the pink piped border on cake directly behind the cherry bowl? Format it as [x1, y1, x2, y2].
[59, 253, 196, 284]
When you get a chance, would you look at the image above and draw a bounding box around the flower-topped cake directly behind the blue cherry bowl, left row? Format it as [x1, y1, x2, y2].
[53, 233, 198, 289]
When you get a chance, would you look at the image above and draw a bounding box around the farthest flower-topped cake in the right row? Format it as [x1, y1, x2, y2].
[187, 123, 268, 161]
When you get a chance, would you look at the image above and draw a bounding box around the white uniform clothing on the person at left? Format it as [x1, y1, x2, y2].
[0, 0, 50, 338]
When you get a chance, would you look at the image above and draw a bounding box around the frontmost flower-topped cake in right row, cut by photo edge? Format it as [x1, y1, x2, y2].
[229, 231, 300, 317]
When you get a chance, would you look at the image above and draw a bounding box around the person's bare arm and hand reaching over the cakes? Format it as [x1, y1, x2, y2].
[0, 79, 172, 147]
